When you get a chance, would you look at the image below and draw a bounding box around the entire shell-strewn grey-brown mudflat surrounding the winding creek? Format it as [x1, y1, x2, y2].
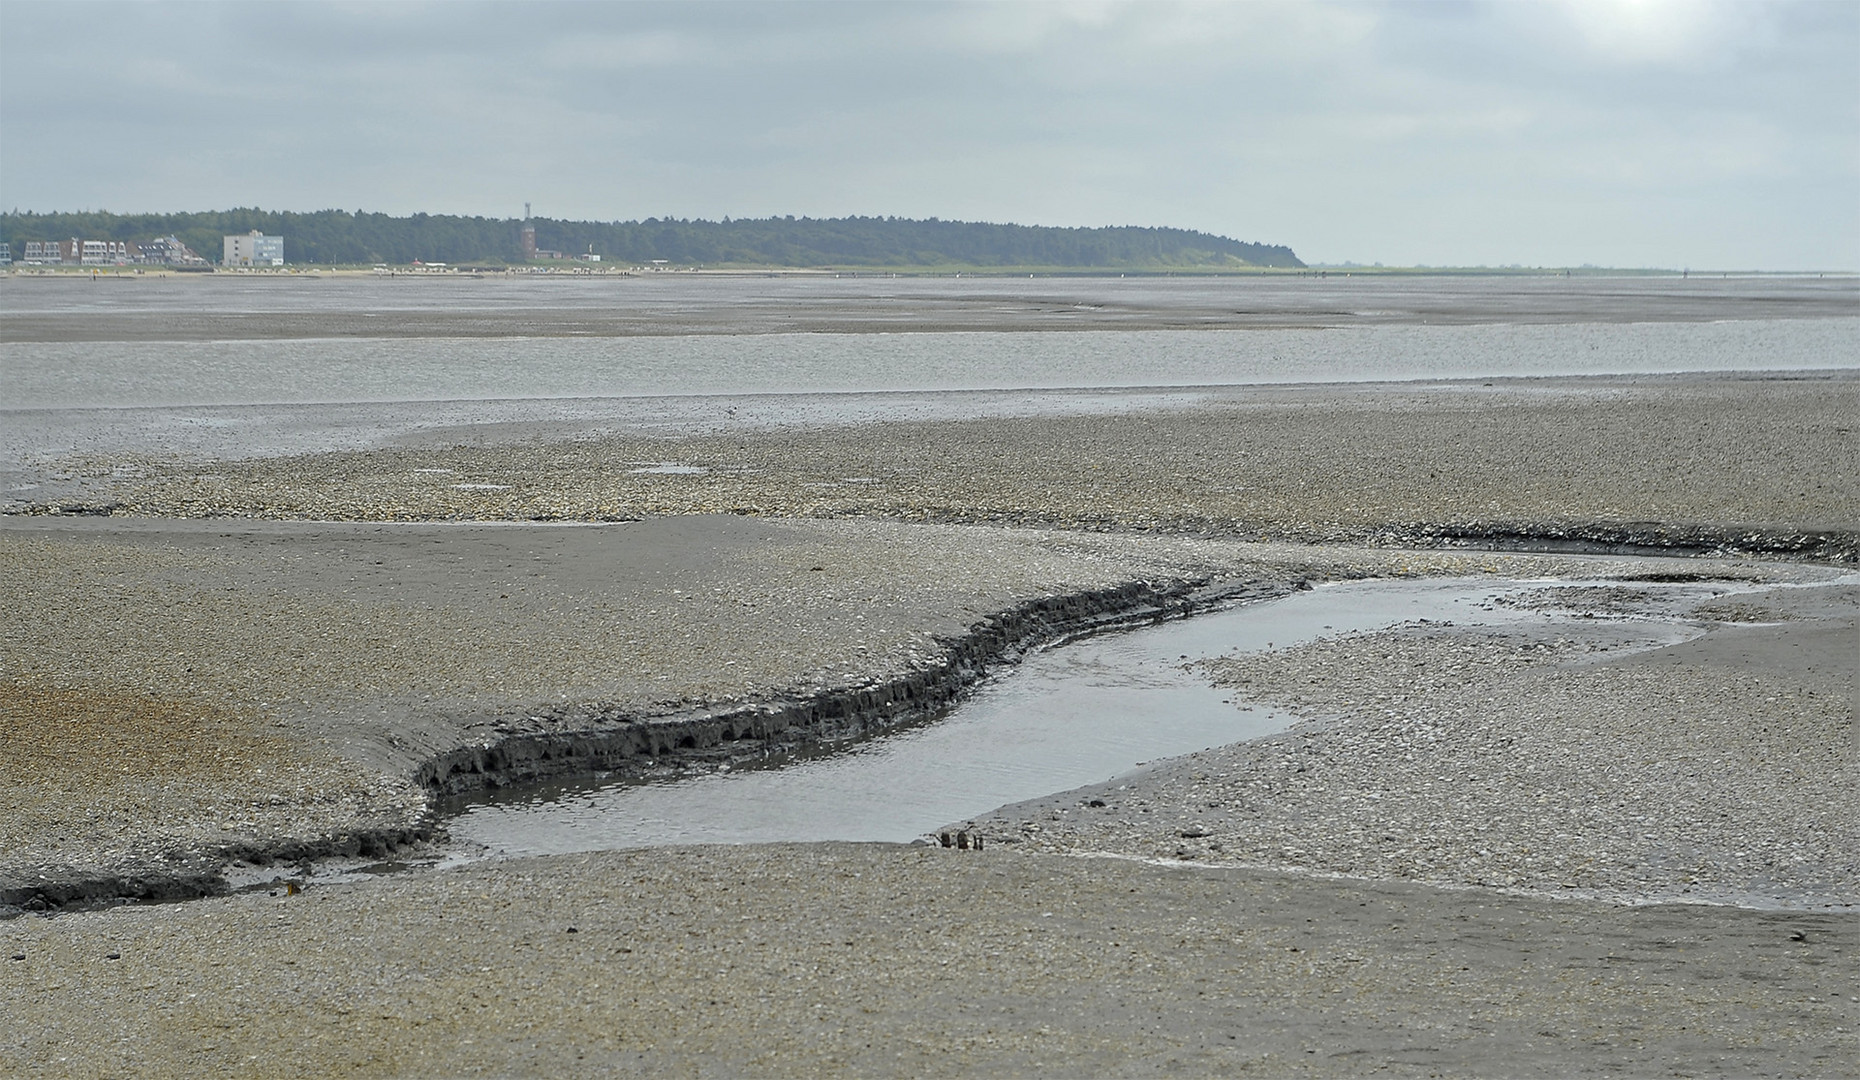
[0, 273, 1860, 1076]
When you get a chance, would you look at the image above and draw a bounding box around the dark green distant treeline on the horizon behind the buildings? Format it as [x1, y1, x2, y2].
[0, 208, 1304, 270]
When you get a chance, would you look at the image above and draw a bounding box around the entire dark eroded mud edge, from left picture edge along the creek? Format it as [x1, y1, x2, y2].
[0, 580, 1309, 918]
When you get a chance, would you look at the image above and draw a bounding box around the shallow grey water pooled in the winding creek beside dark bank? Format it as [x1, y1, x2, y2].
[448, 580, 1651, 855]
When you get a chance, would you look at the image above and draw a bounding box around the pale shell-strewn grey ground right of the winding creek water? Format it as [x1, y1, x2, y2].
[978, 584, 1860, 911]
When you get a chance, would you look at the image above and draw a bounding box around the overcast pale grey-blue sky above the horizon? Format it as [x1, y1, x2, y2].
[0, 0, 1860, 270]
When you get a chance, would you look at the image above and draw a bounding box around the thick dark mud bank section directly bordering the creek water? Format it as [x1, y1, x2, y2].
[413, 580, 1309, 796]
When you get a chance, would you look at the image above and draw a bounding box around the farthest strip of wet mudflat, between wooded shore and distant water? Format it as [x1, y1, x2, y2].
[0, 271, 1854, 342]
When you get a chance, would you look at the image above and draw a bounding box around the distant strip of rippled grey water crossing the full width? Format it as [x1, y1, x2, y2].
[0, 320, 1860, 409]
